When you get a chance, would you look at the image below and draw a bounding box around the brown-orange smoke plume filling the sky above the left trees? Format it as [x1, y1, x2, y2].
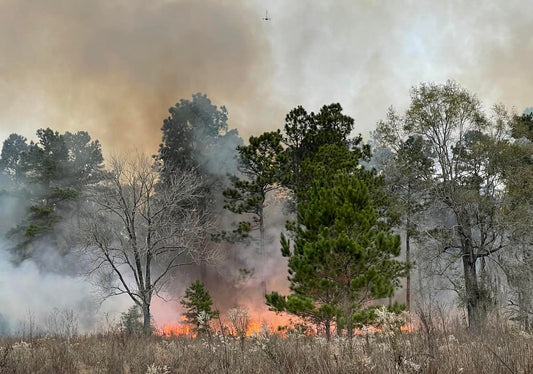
[0, 0, 271, 153]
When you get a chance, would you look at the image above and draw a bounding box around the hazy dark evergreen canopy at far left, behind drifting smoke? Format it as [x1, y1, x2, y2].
[0, 128, 103, 258]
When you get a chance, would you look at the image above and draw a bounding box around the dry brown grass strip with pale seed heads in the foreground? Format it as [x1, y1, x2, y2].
[0, 323, 533, 374]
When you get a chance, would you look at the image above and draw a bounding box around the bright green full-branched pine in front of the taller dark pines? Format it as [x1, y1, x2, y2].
[266, 171, 408, 339]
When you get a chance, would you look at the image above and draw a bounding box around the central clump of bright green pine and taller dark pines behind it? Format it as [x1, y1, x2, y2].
[220, 104, 408, 339]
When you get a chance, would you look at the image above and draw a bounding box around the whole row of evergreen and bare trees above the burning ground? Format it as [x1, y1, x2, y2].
[0, 85, 533, 338]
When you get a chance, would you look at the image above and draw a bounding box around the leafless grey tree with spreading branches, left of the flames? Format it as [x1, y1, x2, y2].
[82, 156, 216, 333]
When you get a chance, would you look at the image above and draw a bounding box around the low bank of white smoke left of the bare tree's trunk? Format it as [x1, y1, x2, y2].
[0, 242, 131, 335]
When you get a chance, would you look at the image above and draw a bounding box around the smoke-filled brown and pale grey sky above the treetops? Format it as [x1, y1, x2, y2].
[0, 0, 533, 154]
